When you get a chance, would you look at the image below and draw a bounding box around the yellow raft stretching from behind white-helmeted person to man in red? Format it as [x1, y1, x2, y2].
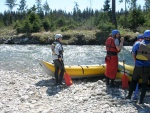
[40, 61, 105, 78]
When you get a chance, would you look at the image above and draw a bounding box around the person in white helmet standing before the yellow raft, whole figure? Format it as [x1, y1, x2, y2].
[51, 34, 65, 86]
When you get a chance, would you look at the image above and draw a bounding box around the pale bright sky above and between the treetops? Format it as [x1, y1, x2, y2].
[0, 0, 145, 13]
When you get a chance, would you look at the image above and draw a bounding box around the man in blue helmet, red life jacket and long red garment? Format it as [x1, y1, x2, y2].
[105, 30, 124, 87]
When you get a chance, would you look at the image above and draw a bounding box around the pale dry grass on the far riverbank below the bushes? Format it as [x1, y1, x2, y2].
[0, 26, 138, 45]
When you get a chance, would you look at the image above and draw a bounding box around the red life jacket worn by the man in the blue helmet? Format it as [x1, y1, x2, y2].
[105, 37, 120, 56]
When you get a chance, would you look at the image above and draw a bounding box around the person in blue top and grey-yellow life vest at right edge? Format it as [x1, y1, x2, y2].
[126, 30, 150, 104]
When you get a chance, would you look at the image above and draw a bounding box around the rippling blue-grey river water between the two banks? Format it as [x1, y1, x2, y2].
[0, 44, 133, 74]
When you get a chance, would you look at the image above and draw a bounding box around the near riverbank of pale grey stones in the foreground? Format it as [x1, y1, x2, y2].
[0, 70, 150, 113]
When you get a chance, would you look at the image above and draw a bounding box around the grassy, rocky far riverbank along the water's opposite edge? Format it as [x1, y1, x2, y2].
[0, 30, 137, 46]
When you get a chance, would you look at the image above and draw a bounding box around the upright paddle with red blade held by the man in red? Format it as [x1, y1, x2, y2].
[122, 49, 129, 97]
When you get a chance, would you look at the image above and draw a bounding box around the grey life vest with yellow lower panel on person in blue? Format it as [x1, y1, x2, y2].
[136, 43, 150, 61]
